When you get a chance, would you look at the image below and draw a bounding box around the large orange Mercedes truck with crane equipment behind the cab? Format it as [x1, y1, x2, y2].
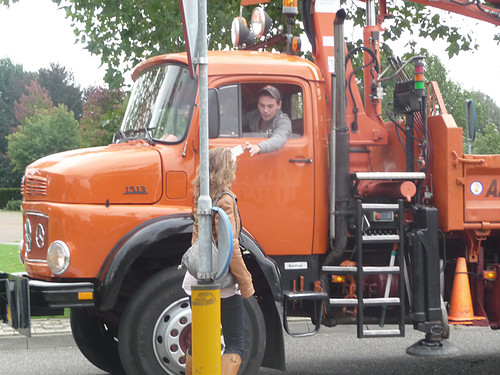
[0, 0, 500, 374]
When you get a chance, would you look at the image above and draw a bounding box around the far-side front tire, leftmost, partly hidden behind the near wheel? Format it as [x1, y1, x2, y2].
[70, 308, 125, 375]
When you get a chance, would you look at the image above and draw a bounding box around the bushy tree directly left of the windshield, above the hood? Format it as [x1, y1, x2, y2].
[79, 87, 127, 147]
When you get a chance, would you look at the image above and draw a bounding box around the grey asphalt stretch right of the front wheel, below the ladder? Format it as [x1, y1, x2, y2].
[259, 326, 500, 375]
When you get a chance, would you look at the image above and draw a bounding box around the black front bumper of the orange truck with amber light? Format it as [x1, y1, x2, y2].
[0, 272, 95, 336]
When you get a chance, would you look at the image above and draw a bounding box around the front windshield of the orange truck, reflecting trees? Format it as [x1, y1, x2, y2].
[120, 65, 196, 143]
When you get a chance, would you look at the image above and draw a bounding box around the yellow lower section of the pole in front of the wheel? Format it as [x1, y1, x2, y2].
[191, 283, 221, 375]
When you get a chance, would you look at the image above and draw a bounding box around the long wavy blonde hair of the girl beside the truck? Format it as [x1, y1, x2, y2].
[193, 147, 237, 204]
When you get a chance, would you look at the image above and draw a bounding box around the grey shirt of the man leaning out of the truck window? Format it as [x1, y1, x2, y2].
[243, 108, 292, 153]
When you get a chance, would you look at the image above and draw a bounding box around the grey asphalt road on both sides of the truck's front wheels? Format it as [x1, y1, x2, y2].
[0, 326, 500, 375]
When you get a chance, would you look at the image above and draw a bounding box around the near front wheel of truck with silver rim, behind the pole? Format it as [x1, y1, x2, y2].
[118, 268, 266, 375]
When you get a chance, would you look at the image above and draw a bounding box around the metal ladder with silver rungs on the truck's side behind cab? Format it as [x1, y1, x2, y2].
[322, 199, 405, 338]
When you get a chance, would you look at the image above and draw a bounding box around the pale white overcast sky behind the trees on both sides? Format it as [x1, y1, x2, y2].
[0, 0, 500, 105]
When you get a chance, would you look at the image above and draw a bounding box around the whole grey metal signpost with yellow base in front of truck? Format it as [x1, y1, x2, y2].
[191, 0, 221, 375]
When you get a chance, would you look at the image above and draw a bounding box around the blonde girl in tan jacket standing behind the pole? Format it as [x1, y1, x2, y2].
[182, 147, 255, 375]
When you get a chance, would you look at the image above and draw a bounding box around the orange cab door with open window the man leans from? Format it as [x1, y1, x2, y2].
[211, 82, 314, 255]
